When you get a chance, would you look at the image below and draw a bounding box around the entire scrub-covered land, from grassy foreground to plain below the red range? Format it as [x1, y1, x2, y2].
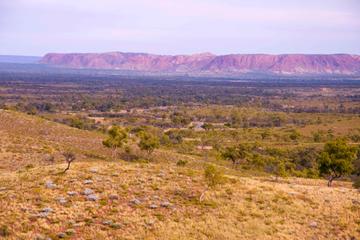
[0, 73, 360, 239]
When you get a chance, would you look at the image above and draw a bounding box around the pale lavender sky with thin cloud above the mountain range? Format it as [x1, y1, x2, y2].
[0, 0, 360, 56]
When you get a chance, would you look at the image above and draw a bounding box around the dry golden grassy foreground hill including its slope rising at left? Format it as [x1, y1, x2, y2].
[0, 111, 360, 239]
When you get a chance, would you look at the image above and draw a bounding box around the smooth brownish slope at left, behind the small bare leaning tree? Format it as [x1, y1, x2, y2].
[0, 110, 110, 171]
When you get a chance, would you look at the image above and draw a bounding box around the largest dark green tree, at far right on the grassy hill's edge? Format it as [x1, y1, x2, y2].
[318, 139, 356, 187]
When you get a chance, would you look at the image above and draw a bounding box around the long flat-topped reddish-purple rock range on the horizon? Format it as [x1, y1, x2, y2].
[40, 52, 360, 75]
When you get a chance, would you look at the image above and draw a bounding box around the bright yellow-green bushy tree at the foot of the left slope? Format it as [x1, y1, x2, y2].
[103, 126, 128, 159]
